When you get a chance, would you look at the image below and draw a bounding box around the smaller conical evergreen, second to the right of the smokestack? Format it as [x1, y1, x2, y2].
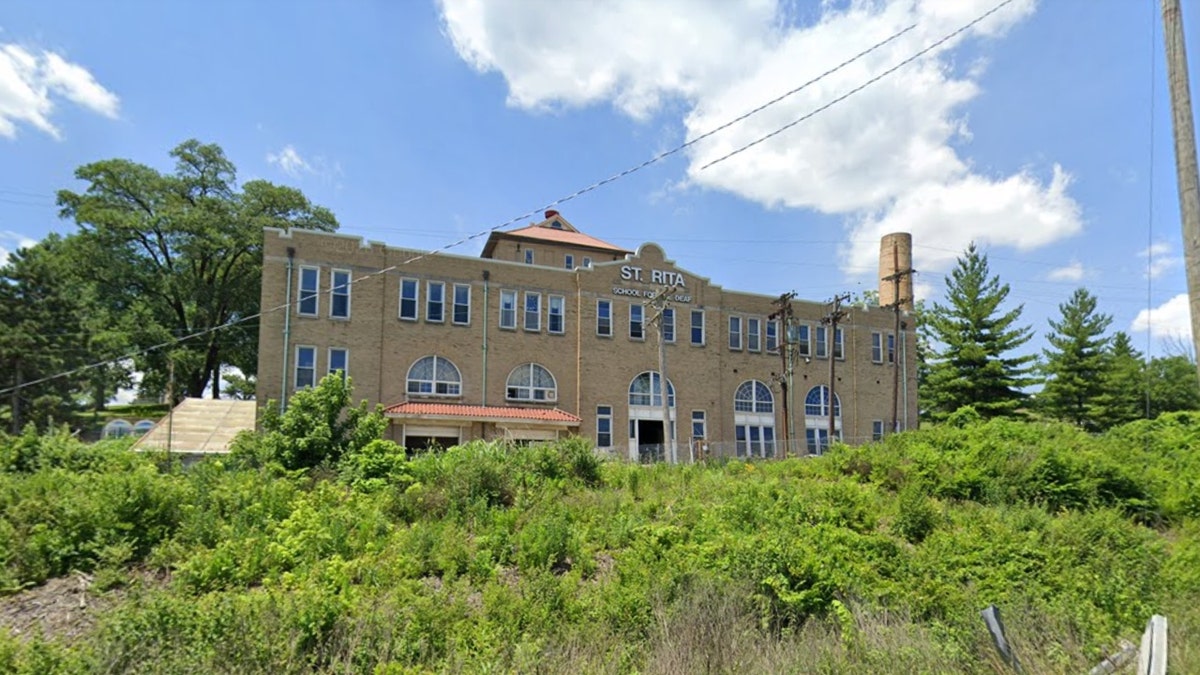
[1038, 288, 1112, 429]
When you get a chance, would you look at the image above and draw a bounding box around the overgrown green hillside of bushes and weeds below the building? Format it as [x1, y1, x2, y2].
[0, 414, 1200, 673]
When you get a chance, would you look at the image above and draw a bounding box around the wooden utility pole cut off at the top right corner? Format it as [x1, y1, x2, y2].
[1163, 0, 1200, 384]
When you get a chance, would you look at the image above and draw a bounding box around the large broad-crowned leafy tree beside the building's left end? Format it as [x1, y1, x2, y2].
[58, 141, 337, 398]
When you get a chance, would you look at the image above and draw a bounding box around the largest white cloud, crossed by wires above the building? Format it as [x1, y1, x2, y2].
[440, 0, 1082, 271]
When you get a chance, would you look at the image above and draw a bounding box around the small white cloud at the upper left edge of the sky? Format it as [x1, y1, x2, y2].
[0, 43, 120, 138]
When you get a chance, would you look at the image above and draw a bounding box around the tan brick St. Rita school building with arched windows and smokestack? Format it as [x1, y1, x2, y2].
[258, 211, 917, 461]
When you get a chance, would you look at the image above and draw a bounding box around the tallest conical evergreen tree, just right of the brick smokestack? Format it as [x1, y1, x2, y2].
[920, 243, 1037, 419]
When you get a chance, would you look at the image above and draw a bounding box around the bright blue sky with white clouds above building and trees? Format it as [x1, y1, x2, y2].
[0, 0, 1200, 352]
